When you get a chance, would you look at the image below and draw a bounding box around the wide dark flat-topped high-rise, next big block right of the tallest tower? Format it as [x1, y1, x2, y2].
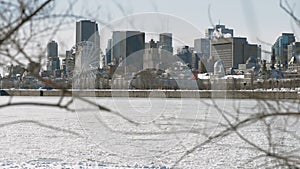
[112, 31, 145, 70]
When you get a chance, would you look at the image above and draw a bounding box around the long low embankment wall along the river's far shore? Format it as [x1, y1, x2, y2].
[5, 89, 300, 99]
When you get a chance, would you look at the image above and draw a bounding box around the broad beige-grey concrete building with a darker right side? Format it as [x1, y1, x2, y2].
[210, 37, 261, 71]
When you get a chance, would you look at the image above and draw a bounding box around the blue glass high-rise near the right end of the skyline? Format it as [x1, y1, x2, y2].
[271, 33, 295, 68]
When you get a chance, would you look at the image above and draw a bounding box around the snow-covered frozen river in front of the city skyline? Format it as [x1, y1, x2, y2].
[0, 97, 300, 168]
